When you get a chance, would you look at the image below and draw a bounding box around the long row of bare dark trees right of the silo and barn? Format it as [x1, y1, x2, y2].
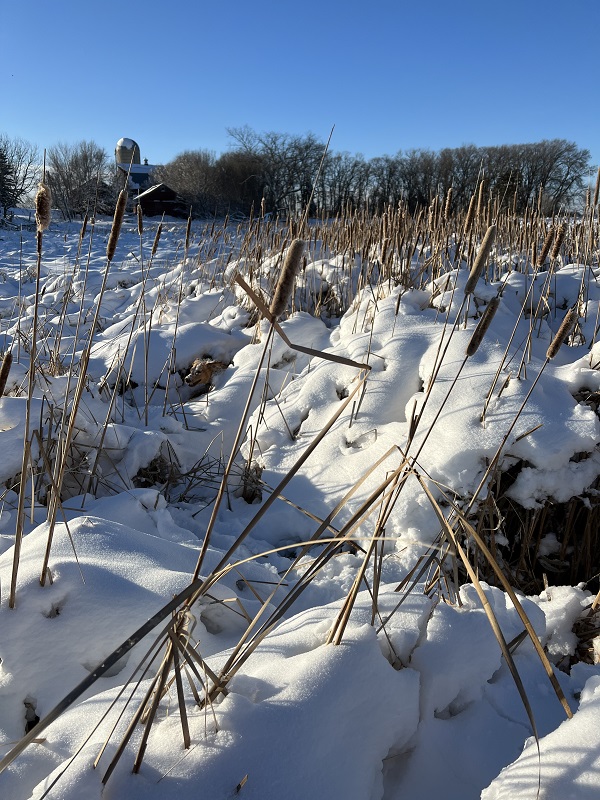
[157, 127, 591, 216]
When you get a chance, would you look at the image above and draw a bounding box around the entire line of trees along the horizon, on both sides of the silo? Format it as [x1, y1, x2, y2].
[0, 127, 591, 219]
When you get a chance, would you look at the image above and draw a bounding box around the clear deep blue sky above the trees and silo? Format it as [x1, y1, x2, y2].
[0, 0, 600, 173]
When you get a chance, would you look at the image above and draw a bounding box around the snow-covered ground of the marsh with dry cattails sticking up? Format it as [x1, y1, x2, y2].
[0, 203, 600, 800]
